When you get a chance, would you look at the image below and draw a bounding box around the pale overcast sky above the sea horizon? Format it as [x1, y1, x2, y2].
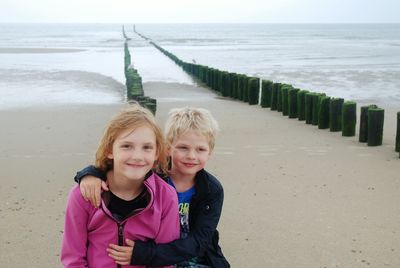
[0, 0, 400, 23]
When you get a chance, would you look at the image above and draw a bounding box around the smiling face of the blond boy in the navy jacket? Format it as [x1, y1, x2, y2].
[169, 130, 211, 179]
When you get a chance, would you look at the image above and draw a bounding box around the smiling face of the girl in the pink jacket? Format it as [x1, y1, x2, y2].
[108, 126, 157, 180]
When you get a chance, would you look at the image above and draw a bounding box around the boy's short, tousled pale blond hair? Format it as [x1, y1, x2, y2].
[165, 107, 219, 151]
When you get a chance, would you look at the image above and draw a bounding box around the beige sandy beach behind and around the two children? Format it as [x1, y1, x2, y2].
[0, 83, 400, 268]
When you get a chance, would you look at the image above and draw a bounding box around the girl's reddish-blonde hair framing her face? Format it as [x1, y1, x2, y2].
[95, 104, 167, 172]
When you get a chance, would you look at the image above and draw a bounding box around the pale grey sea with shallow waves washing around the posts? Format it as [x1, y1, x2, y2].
[0, 24, 400, 110]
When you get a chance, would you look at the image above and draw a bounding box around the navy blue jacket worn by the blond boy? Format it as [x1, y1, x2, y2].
[75, 166, 230, 268]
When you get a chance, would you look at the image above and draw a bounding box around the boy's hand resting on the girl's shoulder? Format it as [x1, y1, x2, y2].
[79, 176, 109, 208]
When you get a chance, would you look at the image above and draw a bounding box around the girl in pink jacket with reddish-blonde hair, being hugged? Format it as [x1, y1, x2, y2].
[61, 105, 179, 268]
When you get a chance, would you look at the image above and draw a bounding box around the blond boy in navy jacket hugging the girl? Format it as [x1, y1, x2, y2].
[75, 107, 230, 268]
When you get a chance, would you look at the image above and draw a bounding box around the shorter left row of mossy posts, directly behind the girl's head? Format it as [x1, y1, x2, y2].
[123, 40, 157, 114]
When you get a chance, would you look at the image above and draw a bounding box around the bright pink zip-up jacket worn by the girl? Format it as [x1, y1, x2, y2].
[61, 173, 179, 268]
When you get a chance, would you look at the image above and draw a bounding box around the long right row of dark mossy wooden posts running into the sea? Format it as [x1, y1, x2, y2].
[135, 27, 400, 157]
